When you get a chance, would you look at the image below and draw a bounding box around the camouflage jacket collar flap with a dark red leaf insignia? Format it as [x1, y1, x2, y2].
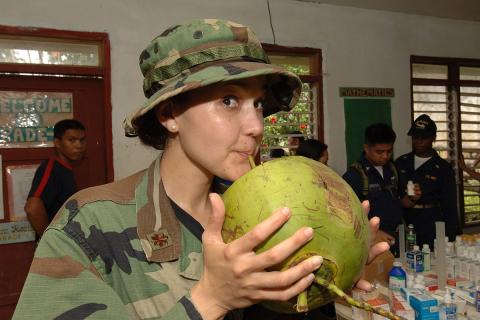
[135, 156, 182, 262]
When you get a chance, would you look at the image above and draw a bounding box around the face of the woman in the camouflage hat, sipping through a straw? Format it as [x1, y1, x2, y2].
[167, 77, 265, 181]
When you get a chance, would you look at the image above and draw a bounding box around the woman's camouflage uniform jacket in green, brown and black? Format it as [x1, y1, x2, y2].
[14, 160, 203, 320]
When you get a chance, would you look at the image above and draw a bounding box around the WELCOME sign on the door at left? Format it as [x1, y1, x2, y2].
[0, 91, 73, 148]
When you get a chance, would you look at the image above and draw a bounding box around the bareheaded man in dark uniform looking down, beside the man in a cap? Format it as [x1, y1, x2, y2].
[343, 123, 403, 255]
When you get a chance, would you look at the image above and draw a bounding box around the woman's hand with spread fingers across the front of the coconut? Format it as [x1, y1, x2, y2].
[191, 193, 322, 320]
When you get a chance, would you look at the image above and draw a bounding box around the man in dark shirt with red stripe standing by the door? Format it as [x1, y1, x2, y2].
[25, 119, 86, 237]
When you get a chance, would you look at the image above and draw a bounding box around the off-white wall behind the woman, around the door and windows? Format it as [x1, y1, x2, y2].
[0, 0, 480, 179]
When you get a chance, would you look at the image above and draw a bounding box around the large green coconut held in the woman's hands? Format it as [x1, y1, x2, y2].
[222, 156, 400, 313]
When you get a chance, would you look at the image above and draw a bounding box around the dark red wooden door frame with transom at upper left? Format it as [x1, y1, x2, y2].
[0, 25, 114, 182]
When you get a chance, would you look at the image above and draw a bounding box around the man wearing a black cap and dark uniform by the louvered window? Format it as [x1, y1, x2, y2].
[395, 114, 458, 248]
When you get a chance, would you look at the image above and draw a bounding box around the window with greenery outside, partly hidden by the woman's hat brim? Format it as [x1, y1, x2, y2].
[261, 45, 323, 161]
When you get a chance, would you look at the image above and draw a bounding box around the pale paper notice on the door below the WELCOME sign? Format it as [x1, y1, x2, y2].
[5, 164, 40, 221]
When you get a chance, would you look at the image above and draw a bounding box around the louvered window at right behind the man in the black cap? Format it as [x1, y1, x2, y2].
[411, 56, 480, 226]
